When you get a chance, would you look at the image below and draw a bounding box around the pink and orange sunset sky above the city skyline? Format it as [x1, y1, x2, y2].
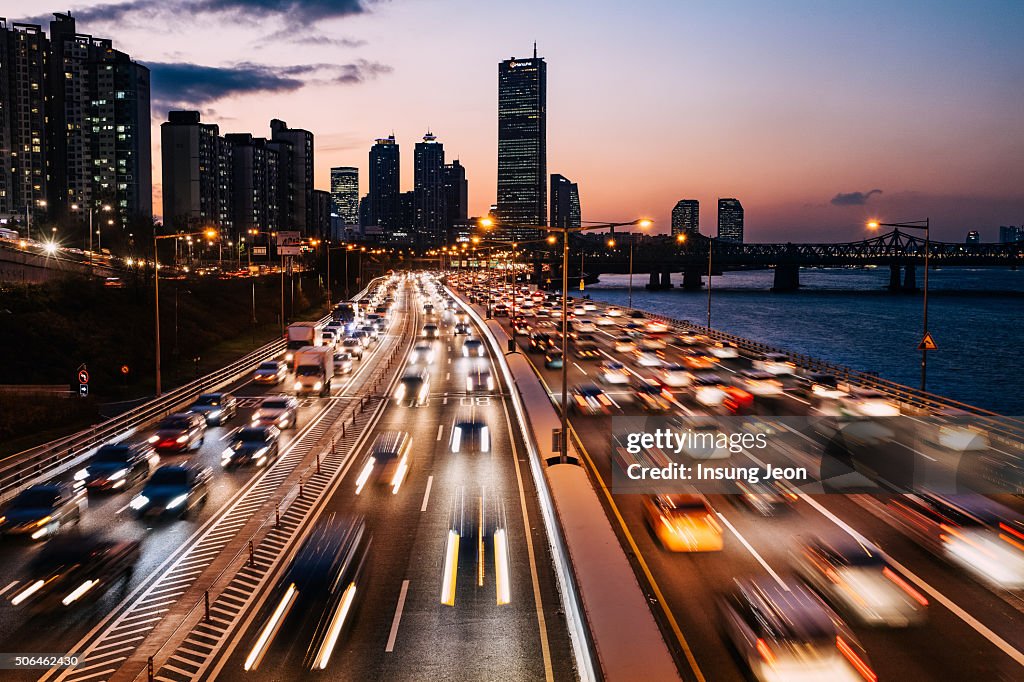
[8, 0, 1024, 242]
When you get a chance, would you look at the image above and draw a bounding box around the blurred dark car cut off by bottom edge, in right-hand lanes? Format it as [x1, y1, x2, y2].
[718, 577, 878, 682]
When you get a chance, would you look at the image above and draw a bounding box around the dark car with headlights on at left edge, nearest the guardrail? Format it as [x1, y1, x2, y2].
[0, 481, 87, 540]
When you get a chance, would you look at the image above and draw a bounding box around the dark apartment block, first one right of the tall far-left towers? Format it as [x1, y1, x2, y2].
[160, 112, 234, 235]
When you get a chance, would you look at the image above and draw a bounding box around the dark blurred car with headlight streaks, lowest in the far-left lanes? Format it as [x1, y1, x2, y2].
[8, 534, 140, 611]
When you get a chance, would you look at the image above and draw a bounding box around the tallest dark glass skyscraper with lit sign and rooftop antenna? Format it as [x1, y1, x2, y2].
[497, 46, 548, 241]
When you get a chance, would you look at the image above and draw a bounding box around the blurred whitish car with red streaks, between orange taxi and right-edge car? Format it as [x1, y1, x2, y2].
[793, 535, 928, 628]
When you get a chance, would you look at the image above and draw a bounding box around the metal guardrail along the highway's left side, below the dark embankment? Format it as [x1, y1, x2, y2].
[0, 278, 383, 502]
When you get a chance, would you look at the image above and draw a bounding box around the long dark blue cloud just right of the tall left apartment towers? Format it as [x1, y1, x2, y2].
[144, 59, 391, 113]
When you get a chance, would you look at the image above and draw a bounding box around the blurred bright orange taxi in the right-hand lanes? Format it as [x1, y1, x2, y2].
[643, 495, 722, 552]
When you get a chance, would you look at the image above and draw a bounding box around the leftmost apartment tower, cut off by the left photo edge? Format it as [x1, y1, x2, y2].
[0, 18, 49, 221]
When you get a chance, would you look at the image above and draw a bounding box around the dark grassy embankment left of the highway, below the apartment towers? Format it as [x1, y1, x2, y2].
[0, 275, 325, 456]
